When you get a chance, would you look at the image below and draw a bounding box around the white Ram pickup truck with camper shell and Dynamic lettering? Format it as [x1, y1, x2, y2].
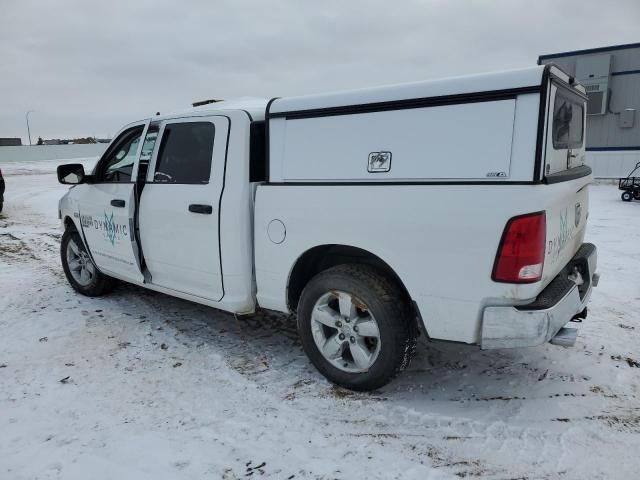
[58, 66, 598, 390]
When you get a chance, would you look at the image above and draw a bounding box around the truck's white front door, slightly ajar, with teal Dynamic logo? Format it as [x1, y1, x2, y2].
[78, 122, 147, 282]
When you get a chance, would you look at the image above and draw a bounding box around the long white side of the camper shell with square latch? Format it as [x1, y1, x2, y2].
[269, 68, 542, 182]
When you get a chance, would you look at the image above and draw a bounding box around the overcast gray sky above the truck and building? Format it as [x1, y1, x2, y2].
[0, 0, 640, 141]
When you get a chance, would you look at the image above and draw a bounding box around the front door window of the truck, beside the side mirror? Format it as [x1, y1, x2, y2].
[96, 127, 143, 183]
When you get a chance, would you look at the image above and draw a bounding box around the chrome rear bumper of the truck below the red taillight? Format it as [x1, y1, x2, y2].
[480, 243, 598, 349]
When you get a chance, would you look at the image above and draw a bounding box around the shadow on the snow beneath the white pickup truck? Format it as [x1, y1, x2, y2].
[102, 284, 604, 404]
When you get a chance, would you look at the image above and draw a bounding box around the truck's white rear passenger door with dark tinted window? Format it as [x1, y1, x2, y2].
[139, 116, 229, 301]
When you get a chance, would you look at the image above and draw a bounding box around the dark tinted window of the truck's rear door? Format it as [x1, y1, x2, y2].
[153, 122, 215, 184]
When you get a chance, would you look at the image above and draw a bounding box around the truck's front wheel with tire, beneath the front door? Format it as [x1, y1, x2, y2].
[60, 229, 115, 297]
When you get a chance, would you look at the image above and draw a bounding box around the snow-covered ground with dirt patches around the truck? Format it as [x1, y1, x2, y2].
[0, 162, 640, 480]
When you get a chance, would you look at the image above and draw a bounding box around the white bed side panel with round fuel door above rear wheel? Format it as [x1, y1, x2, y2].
[255, 184, 581, 343]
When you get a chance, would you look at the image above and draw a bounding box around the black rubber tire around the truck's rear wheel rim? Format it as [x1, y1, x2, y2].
[298, 265, 417, 391]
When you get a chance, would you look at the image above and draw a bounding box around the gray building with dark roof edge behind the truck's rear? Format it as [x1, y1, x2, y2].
[538, 43, 640, 178]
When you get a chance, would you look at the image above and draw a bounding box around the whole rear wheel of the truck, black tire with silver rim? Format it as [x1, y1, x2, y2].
[298, 265, 416, 390]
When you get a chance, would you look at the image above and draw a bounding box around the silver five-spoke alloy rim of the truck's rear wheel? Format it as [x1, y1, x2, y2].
[311, 290, 381, 373]
